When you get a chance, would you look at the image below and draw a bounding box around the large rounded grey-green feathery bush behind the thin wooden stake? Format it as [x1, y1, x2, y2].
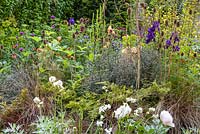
[86, 48, 160, 91]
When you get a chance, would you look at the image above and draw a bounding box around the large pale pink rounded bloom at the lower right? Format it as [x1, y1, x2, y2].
[160, 110, 175, 127]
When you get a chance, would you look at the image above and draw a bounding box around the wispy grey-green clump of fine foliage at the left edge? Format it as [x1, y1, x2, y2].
[0, 69, 37, 102]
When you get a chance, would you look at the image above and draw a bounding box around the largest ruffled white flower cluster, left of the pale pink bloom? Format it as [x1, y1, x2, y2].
[114, 103, 132, 119]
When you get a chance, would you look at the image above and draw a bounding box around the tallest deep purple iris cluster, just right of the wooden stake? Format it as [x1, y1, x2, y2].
[146, 21, 160, 44]
